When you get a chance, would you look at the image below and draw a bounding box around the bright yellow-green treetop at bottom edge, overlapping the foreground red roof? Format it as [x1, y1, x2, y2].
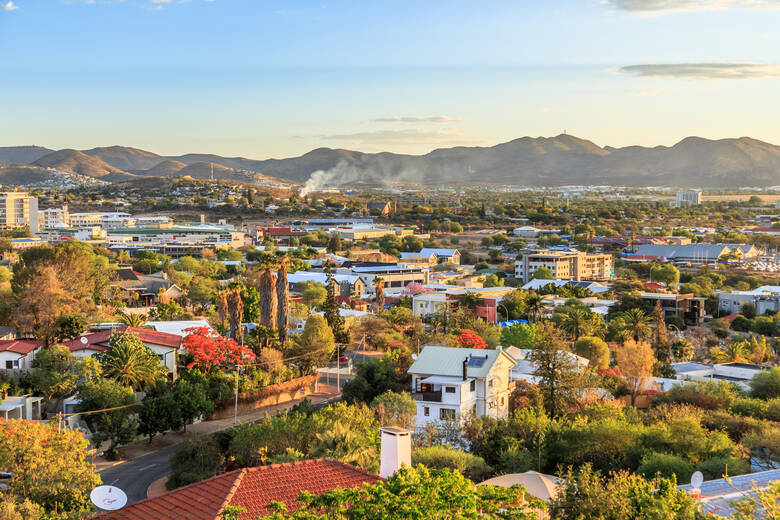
[261, 466, 543, 520]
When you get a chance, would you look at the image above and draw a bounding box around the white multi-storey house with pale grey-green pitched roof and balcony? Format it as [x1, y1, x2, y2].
[407, 345, 515, 428]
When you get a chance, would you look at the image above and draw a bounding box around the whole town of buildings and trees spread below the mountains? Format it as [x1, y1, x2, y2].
[0, 179, 780, 519]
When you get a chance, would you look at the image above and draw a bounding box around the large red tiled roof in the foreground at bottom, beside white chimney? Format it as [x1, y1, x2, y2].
[93, 459, 381, 520]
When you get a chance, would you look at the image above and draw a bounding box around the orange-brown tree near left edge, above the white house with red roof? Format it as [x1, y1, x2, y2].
[14, 267, 68, 346]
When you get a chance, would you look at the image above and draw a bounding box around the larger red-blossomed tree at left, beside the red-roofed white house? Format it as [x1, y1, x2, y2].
[182, 327, 255, 372]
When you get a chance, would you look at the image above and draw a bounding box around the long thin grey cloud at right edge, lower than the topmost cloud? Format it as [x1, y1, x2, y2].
[618, 62, 780, 80]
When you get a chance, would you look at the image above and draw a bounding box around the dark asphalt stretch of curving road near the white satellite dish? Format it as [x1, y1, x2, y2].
[100, 446, 176, 504]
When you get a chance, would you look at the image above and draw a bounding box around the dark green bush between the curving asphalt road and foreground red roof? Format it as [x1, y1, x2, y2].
[166, 437, 225, 489]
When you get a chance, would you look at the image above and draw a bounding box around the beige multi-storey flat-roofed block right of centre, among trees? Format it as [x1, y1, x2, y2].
[515, 250, 614, 283]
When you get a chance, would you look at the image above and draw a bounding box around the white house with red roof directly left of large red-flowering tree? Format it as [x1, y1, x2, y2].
[63, 327, 182, 379]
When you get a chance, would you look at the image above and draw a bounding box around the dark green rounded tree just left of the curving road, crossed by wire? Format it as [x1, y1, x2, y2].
[76, 379, 137, 458]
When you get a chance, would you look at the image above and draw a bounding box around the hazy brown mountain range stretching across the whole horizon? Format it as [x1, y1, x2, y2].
[0, 134, 780, 189]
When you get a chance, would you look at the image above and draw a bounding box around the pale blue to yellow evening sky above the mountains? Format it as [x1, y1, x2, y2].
[0, 0, 780, 159]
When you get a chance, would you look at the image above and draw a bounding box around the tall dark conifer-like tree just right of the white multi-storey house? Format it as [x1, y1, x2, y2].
[529, 322, 582, 417]
